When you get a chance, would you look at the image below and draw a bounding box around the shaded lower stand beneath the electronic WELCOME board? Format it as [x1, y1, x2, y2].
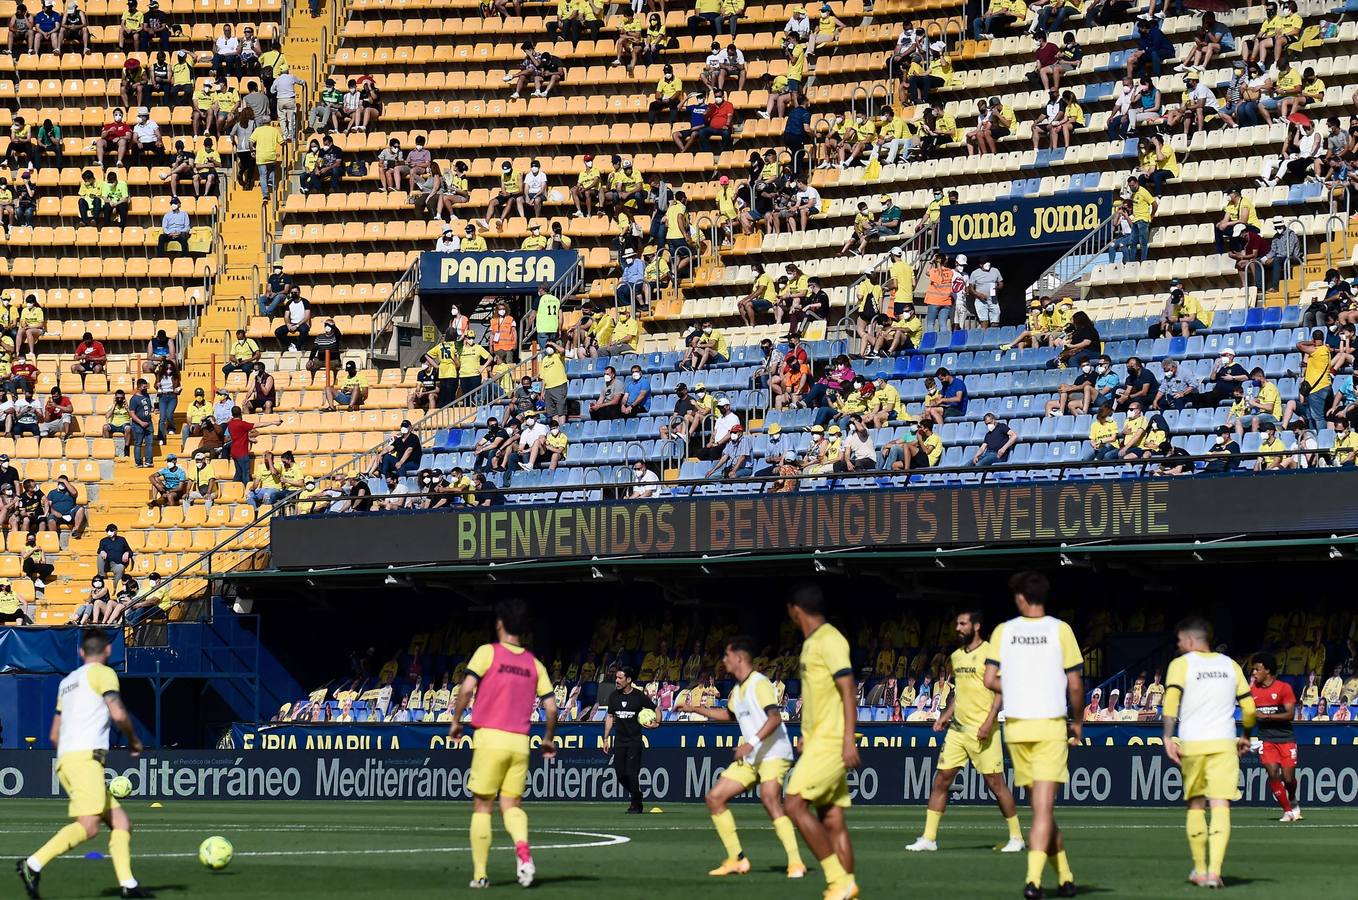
[274, 603, 1358, 722]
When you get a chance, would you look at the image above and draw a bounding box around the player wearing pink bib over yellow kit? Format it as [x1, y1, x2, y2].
[448, 597, 557, 888]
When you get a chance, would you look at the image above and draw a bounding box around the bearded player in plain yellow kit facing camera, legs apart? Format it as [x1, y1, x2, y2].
[906, 610, 1023, 852]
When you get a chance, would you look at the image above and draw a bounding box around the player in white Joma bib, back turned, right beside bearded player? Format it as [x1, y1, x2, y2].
[986, 571, 1085, 900]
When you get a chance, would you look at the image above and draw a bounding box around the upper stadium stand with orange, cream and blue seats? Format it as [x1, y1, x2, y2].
[0, 0, 1358, 623]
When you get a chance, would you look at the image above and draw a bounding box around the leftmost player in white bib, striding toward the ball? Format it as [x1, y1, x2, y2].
[15, 629, 153, 897]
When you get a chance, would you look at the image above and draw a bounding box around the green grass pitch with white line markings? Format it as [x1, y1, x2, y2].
[0, 800, 1358, 900]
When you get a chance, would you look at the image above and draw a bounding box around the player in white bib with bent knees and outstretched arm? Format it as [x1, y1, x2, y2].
[679, 638, 807, 878]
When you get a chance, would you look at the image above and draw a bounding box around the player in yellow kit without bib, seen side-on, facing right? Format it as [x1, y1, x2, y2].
[784, 584, 858, 900]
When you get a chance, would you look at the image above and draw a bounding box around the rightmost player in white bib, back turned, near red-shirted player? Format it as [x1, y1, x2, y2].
[1164, 616, 1255, 888]
